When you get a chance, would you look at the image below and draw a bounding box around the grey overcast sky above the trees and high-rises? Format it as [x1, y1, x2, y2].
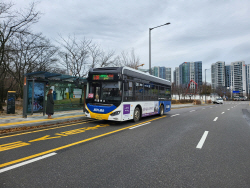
[7, 0, 250, 82]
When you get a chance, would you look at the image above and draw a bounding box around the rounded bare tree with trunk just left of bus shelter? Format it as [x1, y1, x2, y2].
[6, 34, 57, 97]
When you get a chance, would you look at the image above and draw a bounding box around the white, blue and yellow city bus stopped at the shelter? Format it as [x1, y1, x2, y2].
[84, 67, 171, 122]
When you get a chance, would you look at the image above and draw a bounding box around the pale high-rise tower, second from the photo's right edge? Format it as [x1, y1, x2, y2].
[231, 61, 247, 96]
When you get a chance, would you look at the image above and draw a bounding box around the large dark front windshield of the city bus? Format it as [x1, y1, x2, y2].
[88, 82, 122, 103]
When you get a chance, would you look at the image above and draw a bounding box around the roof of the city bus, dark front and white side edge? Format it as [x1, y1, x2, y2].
[89, 67, 171, 86]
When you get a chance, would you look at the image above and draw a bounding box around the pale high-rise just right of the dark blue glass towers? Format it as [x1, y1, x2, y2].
[211, 61, 225, 89]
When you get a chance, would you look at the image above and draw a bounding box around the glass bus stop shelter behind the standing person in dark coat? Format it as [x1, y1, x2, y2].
[23, 71, 87, 118]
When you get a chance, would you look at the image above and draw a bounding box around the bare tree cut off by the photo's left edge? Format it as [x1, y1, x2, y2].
[0, 2, 40, 110]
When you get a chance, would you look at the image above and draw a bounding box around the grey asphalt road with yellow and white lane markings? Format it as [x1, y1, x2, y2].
[0, 101, 250, 188]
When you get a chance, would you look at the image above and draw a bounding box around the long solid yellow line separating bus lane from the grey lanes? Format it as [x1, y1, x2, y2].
[0, 116, 166, 168]
